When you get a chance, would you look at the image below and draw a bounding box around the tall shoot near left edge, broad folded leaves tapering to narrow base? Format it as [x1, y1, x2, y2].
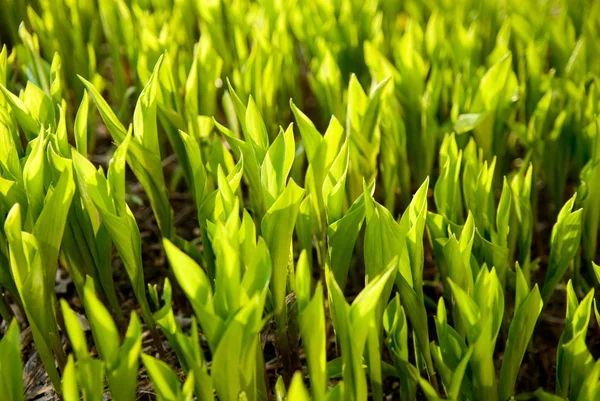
[4, 150, 75, 385]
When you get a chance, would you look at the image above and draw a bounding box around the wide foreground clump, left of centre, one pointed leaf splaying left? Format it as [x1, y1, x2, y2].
[164, 227, 271, 400]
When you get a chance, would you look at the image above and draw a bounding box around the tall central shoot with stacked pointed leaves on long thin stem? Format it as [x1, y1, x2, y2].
[213, 87, 304, 374]
